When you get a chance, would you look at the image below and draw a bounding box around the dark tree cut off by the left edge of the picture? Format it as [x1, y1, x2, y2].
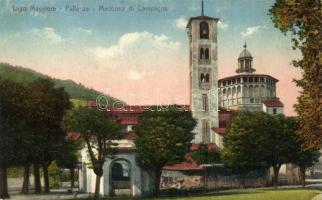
[0, 80, 23, 199]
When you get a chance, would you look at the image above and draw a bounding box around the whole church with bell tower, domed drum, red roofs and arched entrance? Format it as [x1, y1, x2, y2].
[79, 0, 283, 196]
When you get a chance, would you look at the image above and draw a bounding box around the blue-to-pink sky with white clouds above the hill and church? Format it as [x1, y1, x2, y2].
[0, 0, 301, 115]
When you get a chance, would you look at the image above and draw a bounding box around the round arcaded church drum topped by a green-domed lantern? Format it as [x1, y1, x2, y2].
[218, 43, 280, 112]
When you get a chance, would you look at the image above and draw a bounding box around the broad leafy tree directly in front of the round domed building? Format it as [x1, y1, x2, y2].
[223, 111, 295, 186]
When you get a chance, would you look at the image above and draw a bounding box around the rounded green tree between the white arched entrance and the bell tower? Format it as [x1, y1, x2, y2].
[134, 107, 196, 196]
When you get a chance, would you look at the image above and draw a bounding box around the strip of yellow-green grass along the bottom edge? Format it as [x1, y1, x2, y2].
[80, 189, 320, 200]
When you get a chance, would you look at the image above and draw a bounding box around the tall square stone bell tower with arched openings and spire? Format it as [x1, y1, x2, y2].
[187, 1, 218, 144]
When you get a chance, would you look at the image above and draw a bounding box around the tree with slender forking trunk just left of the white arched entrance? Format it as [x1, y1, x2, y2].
[64, 107, 122, 198]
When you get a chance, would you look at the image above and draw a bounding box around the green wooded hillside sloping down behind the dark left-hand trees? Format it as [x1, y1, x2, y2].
[0, 63, 117, 102]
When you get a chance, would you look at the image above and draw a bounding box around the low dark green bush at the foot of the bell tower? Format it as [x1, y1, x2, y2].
[188, 144, 221, 164]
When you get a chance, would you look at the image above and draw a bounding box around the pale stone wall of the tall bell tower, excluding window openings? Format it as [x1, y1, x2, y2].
[189, 20, 218, 143]
